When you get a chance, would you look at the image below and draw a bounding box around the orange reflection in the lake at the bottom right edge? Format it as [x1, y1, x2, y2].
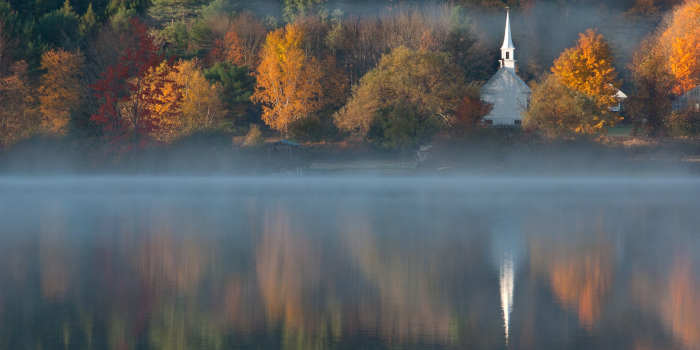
[662, 258, 700, 349]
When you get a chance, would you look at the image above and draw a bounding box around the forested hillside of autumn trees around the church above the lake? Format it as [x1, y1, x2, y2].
[0, 0, 700, 156]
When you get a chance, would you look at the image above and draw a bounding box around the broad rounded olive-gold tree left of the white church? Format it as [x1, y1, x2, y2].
[334, 47, 466, 136]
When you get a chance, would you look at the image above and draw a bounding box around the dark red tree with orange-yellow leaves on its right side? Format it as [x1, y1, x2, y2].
[91, 19, 179, 145]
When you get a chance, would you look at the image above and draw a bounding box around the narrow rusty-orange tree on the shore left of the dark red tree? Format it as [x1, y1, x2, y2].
[39, 49, 85, 135]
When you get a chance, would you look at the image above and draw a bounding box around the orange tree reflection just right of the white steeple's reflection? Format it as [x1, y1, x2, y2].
[531, 239, 613, 329]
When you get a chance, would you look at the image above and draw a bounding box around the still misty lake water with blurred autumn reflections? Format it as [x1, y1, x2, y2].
[0, 177, 700, 350]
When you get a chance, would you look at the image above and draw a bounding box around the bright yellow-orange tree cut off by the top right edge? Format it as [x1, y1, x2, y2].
[658, 0, 700, 95]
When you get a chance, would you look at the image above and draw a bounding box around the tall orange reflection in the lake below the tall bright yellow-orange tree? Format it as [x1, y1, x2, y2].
[256, 211, 320, 330]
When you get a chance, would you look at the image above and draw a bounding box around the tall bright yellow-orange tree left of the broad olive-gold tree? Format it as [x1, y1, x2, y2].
[251, 23, 323, 134]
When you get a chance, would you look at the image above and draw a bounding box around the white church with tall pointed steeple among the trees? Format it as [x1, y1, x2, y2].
[481, 11, 530, 126]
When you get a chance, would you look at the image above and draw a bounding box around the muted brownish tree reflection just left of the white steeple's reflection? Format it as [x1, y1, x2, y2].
[345, 218, 452, 342]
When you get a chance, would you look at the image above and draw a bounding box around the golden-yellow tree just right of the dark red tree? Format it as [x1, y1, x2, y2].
[171, 61, 226, 134]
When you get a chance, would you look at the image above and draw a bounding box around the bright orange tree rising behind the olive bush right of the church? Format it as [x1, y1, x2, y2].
[552, 29, 618, 110]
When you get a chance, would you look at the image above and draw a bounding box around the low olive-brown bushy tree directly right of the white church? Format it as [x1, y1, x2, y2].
[523, 74, 607, 138]
